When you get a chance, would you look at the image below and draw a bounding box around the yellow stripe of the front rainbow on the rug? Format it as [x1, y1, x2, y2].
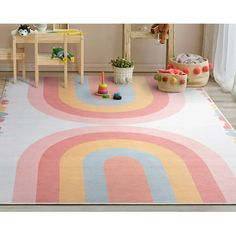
[60, 139, 202, 203]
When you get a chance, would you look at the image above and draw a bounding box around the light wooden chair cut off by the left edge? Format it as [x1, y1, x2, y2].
[0, 48, 26, 79]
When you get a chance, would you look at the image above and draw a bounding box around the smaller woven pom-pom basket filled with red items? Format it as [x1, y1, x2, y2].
[154, 69, 187, 93]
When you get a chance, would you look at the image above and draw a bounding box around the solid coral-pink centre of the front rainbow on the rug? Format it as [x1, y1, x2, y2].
[104, 157, 153, 203]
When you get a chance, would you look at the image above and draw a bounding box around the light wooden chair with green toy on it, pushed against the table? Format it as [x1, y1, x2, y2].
[34, 33, 68, 88]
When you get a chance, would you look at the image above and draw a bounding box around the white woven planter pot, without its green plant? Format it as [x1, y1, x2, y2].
[113, 67, 134, 84]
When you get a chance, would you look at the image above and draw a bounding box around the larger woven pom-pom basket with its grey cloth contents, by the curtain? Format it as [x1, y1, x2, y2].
[167, 53, 213, 87]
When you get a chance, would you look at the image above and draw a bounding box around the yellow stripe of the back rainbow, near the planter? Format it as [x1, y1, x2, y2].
[58, 77, 153, 112]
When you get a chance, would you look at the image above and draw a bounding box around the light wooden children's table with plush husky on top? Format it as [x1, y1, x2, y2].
[13, 30, 84, 83]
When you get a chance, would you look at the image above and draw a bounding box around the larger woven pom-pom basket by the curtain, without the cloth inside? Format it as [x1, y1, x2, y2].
[169, 58, 210, 87]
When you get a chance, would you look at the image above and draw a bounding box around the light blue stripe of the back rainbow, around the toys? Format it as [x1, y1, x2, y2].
[75, 77, 135, 106]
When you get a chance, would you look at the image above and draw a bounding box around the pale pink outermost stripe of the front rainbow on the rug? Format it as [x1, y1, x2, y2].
[13, 126, 236, 202]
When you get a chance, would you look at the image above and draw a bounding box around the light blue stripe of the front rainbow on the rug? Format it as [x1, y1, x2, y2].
[83, 148, 176, 203]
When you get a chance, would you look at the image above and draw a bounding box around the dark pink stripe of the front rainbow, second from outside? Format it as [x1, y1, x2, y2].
[36, 132, 225, 203]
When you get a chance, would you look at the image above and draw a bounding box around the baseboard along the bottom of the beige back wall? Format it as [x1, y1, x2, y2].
[0, 63, 165, 72]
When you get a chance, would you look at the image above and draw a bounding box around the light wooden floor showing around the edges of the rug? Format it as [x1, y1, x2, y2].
[0, 72, 236, 212]
